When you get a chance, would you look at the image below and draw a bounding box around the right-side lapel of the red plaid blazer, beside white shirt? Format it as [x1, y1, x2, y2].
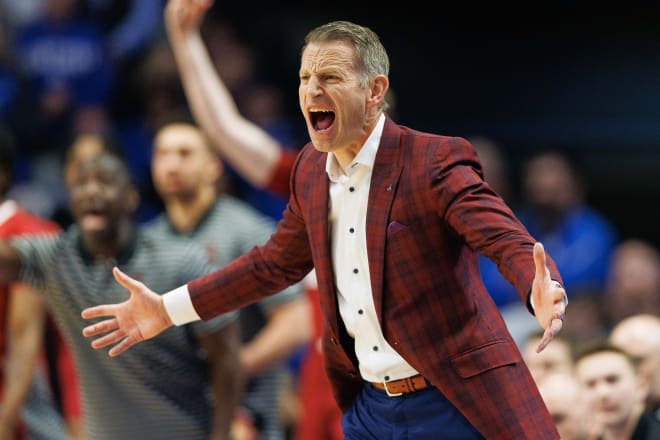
[366, 118, 403, 327]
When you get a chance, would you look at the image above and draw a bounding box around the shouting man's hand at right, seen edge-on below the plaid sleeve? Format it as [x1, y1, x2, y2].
[531, 242, 568, 353]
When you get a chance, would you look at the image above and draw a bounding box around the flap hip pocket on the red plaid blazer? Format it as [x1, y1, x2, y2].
[451, 341, 521, 379]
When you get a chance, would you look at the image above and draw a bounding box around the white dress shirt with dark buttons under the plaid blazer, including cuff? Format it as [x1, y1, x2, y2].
[163, 115, 417, 382]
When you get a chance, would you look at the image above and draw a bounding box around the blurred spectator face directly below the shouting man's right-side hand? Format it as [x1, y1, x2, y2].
[522, 339, 573, 383]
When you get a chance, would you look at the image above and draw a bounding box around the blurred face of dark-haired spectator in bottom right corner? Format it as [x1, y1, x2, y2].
[576, 352, 644, 427]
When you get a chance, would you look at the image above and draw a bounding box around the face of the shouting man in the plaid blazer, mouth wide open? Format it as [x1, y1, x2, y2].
[299, 41, 370, 160]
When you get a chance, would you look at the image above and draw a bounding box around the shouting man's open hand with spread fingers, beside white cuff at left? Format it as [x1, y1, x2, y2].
[82, 267, 173, 356]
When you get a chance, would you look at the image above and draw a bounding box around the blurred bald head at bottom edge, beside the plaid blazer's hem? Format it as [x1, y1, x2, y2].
[538, 372, 598, 440]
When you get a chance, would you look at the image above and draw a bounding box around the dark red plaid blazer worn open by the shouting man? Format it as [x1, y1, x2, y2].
[188, 117, 561, 440]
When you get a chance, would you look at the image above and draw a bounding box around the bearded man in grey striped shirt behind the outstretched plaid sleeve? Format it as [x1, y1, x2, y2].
[150, 118, 311, 440]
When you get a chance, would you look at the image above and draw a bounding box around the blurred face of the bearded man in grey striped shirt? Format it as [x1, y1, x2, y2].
[151, 124, 220, 201]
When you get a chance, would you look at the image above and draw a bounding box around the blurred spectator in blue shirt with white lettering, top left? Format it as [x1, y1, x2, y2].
[14, 0, 113, 152]
